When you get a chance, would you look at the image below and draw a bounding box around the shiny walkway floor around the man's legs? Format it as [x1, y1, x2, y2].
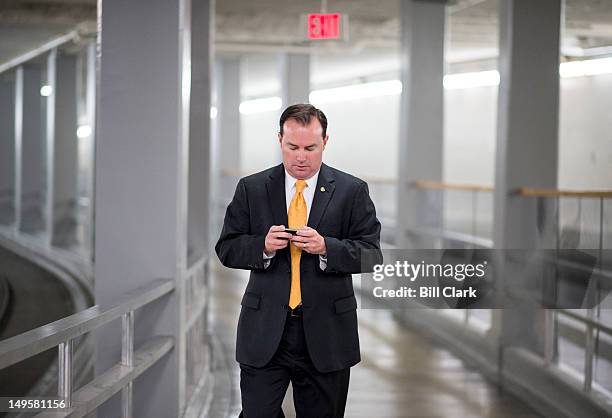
[209, 267, 539, 418]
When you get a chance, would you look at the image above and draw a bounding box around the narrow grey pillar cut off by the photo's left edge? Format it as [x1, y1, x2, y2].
[0, 72, 16, 226]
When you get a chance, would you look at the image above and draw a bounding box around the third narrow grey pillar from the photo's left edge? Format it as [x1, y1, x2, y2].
[46, 54, 79, 246]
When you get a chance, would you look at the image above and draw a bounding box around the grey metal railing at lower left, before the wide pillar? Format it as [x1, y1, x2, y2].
[0, 279, 175, 417]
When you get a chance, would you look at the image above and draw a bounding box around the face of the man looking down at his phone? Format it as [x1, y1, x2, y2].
[278, 118, 329, 180]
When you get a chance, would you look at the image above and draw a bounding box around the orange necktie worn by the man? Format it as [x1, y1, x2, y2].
[287, 180, 308, 309]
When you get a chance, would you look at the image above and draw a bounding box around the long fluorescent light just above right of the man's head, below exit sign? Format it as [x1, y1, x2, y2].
[309, 80, 402, 105]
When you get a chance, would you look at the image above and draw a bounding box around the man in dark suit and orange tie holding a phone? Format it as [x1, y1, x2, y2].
[215, 104, 382, 418]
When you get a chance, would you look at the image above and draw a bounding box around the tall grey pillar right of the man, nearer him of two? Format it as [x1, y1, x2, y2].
[396, 0, 446, 248]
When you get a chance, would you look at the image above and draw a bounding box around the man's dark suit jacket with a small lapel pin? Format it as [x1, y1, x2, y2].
[215, 164, 382, 372]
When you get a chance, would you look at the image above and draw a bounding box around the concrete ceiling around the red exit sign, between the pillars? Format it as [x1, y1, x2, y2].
[0, 0, 612, 63]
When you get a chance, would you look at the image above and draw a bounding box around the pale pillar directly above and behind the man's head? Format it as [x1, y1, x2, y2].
[278, 54, 310, 109]
